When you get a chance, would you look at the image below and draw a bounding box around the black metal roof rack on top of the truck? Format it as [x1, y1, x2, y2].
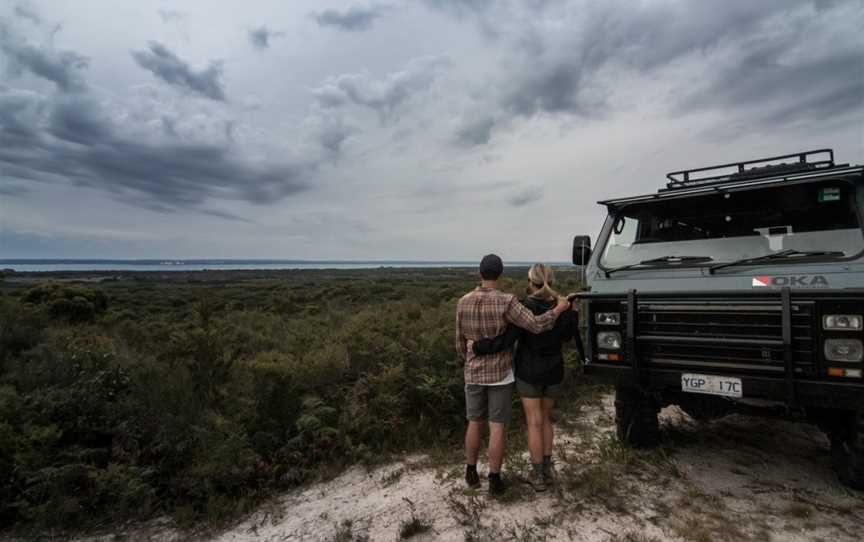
[659, 149, 834, 192]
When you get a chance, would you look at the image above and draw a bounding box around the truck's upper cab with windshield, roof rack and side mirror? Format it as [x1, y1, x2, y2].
[574, 150, 864, 278]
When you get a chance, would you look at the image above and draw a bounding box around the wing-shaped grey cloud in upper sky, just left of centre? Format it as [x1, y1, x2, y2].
[312, 56, 447, 115]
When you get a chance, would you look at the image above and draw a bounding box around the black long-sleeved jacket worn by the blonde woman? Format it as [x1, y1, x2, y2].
[474, 296, 581, 386]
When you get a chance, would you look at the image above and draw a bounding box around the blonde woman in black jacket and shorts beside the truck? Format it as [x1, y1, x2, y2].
[473, 263, 578, 491]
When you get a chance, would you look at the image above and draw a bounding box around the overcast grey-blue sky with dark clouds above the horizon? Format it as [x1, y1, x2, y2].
[0, 0, 864, 261]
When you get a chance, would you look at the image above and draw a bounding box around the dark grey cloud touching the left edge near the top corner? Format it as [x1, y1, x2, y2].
[0, 20, 89, 92]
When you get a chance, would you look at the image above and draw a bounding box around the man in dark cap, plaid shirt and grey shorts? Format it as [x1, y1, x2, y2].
[456, 254, 570, 494]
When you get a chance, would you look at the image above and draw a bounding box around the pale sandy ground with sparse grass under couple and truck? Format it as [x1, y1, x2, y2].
[45, 395, 864, 542]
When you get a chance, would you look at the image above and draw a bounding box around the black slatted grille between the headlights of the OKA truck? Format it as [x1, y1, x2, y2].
[622, 300, 815, 374]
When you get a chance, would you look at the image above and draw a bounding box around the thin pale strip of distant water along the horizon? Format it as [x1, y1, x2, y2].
[0, 259, 566, 272]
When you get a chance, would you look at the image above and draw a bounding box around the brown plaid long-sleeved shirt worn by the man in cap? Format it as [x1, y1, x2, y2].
[456, 287, 556, 384]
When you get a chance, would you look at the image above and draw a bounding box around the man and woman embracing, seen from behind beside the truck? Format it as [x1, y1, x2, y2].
[456, 254, 578, 494]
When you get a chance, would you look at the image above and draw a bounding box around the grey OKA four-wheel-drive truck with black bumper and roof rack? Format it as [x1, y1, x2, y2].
[573, 149, 864, 489]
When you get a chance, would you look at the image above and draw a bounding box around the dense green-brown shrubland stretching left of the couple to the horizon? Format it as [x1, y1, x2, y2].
[0, 270, 577, 539]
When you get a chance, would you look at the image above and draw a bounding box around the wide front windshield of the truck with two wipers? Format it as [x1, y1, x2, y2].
[600, 180, 864, 269]
